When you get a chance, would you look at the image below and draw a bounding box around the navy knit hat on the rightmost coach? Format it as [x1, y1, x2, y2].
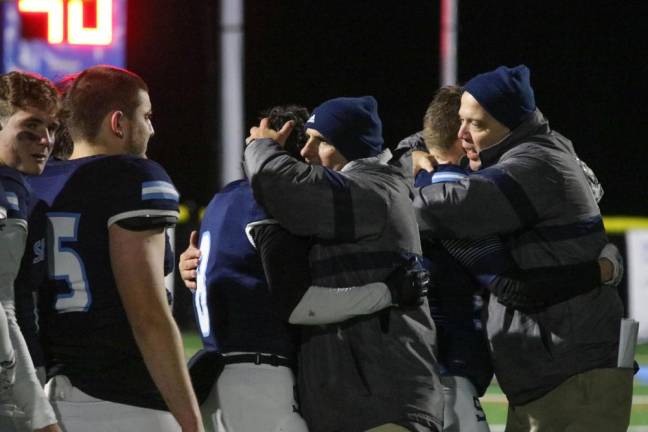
[464, 65, 536, 130]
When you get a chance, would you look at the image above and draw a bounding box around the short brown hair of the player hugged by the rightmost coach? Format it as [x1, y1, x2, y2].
[423, 85, 463, 151]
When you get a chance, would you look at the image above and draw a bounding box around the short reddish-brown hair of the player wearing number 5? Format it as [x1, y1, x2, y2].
[63, 65, 148, 140]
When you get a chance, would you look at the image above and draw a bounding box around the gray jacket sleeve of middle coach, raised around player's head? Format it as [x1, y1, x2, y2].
[245, 139, 387, 242]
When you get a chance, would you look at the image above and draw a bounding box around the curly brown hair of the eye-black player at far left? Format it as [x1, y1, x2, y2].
[0, 71, 61, 117]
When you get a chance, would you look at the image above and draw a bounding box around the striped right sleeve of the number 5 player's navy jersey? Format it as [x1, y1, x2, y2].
[107, 157, 180, 227]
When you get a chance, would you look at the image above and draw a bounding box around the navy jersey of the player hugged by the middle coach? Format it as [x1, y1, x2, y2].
[194, 180, 294, 357]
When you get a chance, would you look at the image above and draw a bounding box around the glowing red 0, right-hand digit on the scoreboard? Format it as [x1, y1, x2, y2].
[67, 0, 112, 45]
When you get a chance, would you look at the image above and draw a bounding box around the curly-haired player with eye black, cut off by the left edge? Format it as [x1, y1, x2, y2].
[0, 72, 60, 431]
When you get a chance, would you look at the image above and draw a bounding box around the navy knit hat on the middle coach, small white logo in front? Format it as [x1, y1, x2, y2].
[304, 96, 383, 161]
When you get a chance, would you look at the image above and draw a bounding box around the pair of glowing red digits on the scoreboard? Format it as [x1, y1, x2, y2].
[18, 0, 113, 45]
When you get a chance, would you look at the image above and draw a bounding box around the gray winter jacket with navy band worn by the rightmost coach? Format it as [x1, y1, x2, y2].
[414, 111, 623, 405]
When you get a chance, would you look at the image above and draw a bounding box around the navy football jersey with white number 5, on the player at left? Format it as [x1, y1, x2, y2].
[30, 155, 179, 409]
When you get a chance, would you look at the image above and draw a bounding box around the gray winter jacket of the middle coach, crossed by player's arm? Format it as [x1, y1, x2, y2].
[245, 139, 443, 432]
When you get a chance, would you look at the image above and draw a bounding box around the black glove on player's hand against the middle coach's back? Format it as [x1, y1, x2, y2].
[385, 257, 432, 308]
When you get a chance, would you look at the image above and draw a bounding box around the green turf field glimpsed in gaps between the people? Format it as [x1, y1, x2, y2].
[184, 333, 648, 426]
